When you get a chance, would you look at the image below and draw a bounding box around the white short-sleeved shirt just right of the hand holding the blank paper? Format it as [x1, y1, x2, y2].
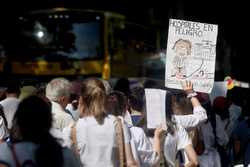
[164, 124, 192, 167]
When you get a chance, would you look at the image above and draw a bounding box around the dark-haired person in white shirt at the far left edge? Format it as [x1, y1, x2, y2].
[0, 83, 20, 129]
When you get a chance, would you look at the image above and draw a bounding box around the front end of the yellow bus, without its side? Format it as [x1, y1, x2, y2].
[0, 8, 125, 79]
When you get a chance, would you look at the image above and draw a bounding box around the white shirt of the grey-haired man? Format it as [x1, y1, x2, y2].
[51, 101, 74, 131]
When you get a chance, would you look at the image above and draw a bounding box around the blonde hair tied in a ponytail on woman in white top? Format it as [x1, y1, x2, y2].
[81, 78, 106, 124]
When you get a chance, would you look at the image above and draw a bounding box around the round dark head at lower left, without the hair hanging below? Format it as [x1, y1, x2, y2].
[14, 96, 52, 142]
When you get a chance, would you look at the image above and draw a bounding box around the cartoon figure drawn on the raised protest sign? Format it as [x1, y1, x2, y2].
[171, 39, 192, 79]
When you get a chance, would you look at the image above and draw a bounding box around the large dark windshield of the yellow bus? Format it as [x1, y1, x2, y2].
[8, 14, 103, 61]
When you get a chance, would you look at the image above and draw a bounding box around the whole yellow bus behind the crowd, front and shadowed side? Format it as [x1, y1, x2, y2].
[0, 8, 161, 83]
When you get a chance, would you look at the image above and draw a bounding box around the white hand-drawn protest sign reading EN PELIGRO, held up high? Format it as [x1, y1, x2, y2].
[165, 19, 218, 93]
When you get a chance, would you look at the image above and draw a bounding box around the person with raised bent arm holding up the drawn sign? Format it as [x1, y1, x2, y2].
[165, 81, 208, 166]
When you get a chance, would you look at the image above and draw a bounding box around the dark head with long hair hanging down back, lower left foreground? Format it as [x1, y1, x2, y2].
[14, 96, 63, 167]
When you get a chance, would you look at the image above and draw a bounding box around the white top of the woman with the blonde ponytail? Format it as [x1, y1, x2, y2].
[76, 115, 130, 167]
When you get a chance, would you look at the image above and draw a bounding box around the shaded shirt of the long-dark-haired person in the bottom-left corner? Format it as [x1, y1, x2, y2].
[0, 142, 80, 167]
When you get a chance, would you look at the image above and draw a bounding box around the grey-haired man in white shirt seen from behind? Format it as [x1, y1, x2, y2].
[46, 78, 74, 131]
